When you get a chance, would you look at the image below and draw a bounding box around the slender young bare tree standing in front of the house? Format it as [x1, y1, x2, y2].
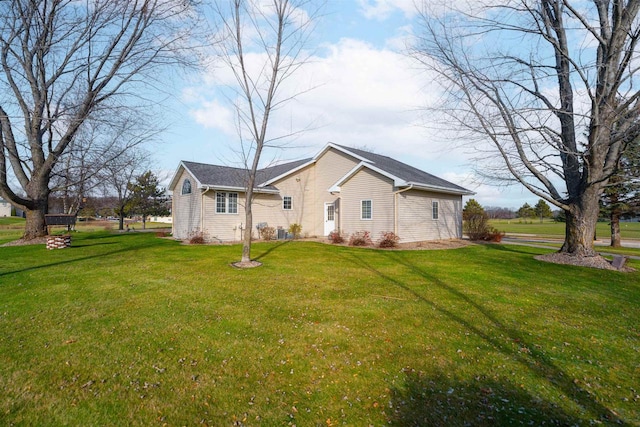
[215, 0, 320, 265]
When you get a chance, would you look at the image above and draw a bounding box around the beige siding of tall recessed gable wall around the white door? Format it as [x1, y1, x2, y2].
[309, 148, 360, 236]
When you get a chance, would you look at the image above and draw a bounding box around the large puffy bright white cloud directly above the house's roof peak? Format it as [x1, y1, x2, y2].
[262, 39, 450, 157]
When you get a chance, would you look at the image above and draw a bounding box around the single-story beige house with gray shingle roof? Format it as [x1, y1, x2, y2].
[169, 143, 473, 242]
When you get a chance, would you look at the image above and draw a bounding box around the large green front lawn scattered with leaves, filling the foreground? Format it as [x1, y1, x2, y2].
[0, 232, 640, 426]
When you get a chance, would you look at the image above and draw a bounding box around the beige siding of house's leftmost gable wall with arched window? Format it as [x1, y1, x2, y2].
[171, 170, 202, 239]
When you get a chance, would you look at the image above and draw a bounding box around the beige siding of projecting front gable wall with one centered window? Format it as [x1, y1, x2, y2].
[340, 169, 394, 241]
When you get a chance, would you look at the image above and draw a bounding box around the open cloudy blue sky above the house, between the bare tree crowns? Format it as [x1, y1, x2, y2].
[154, 0, 537, 208]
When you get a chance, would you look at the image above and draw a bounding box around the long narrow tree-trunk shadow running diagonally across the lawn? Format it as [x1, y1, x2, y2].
[342, 247, 624, 425]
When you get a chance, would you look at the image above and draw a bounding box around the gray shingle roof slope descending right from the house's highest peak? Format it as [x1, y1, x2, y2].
[335, 144, 470, 192]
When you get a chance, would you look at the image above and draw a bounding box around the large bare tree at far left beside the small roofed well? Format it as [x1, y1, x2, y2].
[0, 0, 196, 239]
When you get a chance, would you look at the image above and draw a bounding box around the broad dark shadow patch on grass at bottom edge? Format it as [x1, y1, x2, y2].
[389, 368, 582, 427]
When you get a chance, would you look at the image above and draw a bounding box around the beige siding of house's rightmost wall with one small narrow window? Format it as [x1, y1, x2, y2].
[397, 190, 462, 242]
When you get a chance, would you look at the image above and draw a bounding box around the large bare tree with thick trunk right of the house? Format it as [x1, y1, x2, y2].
[413, 0, 640, 256]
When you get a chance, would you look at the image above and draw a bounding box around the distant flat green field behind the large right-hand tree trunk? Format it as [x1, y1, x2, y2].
[490, 218, 640, 239]
